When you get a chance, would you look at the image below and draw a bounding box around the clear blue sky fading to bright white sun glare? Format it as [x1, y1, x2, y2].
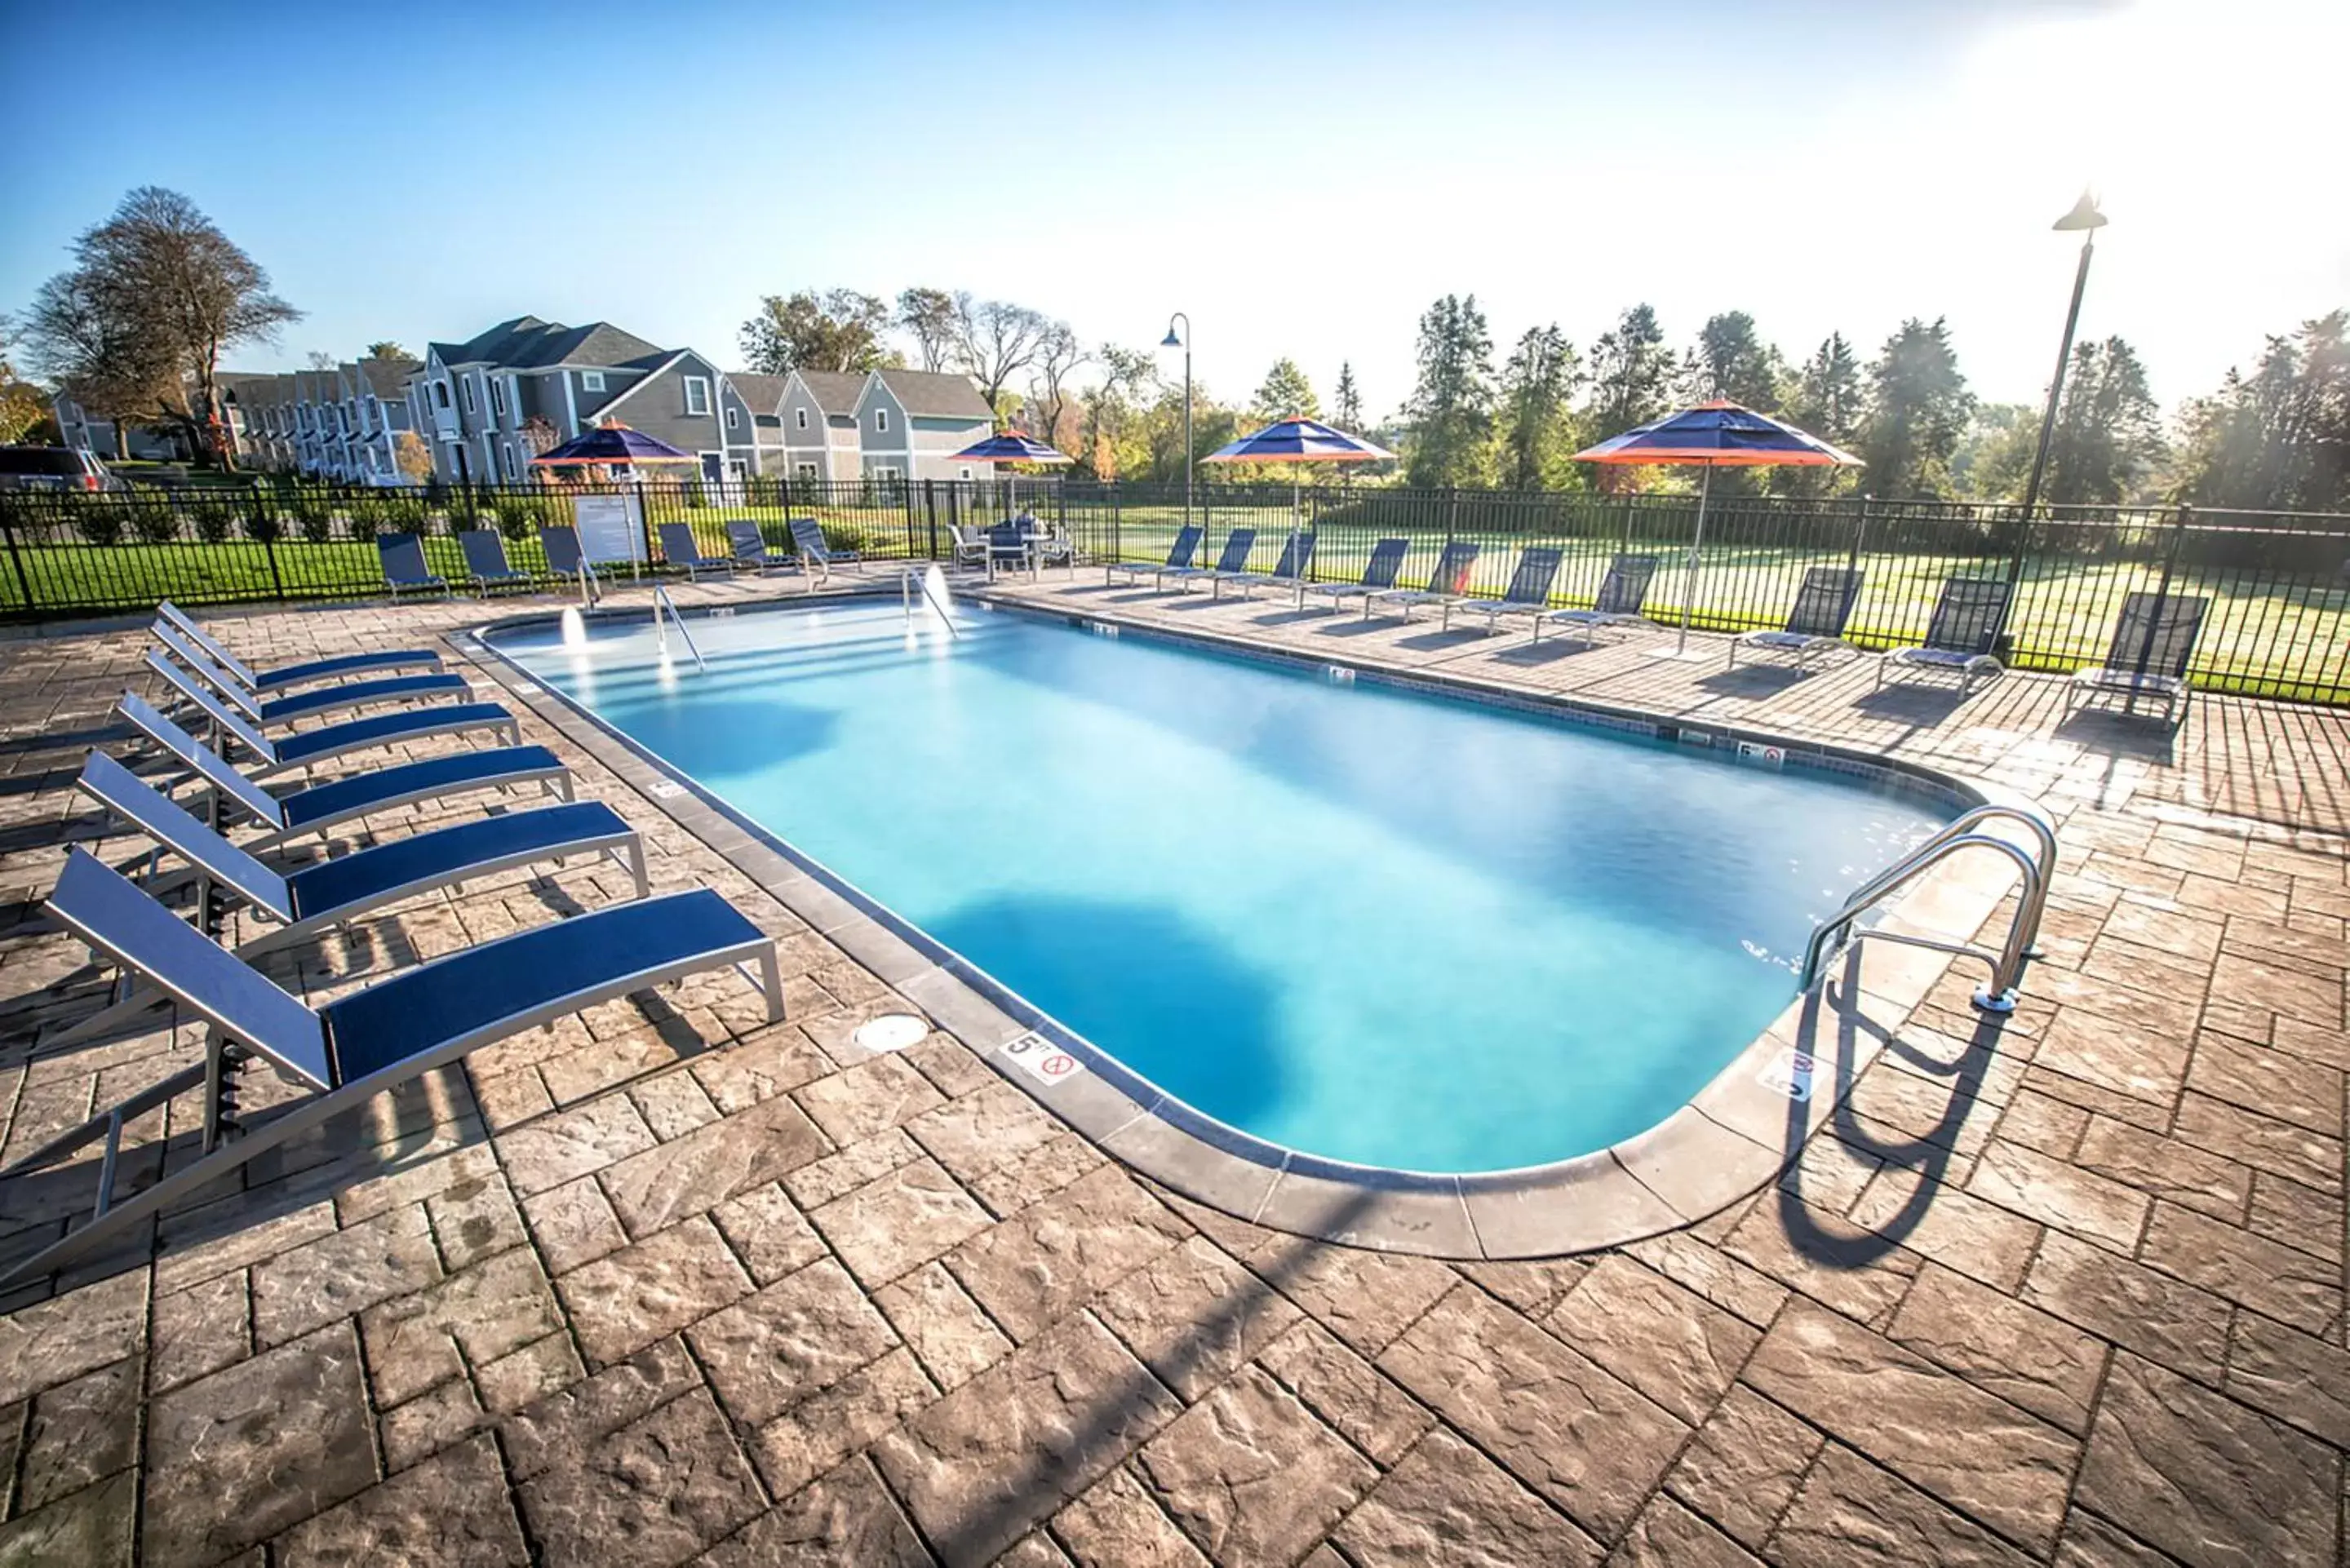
[0, 0, 2350, 416]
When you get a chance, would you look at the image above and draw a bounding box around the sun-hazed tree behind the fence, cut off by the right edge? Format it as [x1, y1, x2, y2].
[2179, 310, 2350, 512]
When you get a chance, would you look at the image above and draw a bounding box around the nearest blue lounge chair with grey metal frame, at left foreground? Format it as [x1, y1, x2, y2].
[0, 848, 783, 1288]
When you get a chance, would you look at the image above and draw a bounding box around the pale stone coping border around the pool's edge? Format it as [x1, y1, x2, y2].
[463, 583, 2021, 1260]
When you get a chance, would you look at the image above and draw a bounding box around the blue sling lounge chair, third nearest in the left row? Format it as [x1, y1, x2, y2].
[115, 691, 576, 853]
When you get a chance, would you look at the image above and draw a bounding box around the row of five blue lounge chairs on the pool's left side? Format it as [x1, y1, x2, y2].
[0, 605, 783, 1288]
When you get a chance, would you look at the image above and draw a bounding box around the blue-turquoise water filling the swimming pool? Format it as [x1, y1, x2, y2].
[499, 602, 1941, 1171]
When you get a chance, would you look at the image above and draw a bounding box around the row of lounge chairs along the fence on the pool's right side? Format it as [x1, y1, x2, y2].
[1105, 525, 2209, 724]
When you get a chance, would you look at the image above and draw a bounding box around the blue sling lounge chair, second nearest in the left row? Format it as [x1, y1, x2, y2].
[75, 752, 651, 957]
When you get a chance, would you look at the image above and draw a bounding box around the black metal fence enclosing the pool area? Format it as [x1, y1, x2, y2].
[0, 477, 2350, 703]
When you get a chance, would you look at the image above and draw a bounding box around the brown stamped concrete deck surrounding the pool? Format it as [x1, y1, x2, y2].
[0, 571, 2350, 1568]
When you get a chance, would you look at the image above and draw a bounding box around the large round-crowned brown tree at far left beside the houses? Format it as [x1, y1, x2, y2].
[33, 186, 301, 467]
